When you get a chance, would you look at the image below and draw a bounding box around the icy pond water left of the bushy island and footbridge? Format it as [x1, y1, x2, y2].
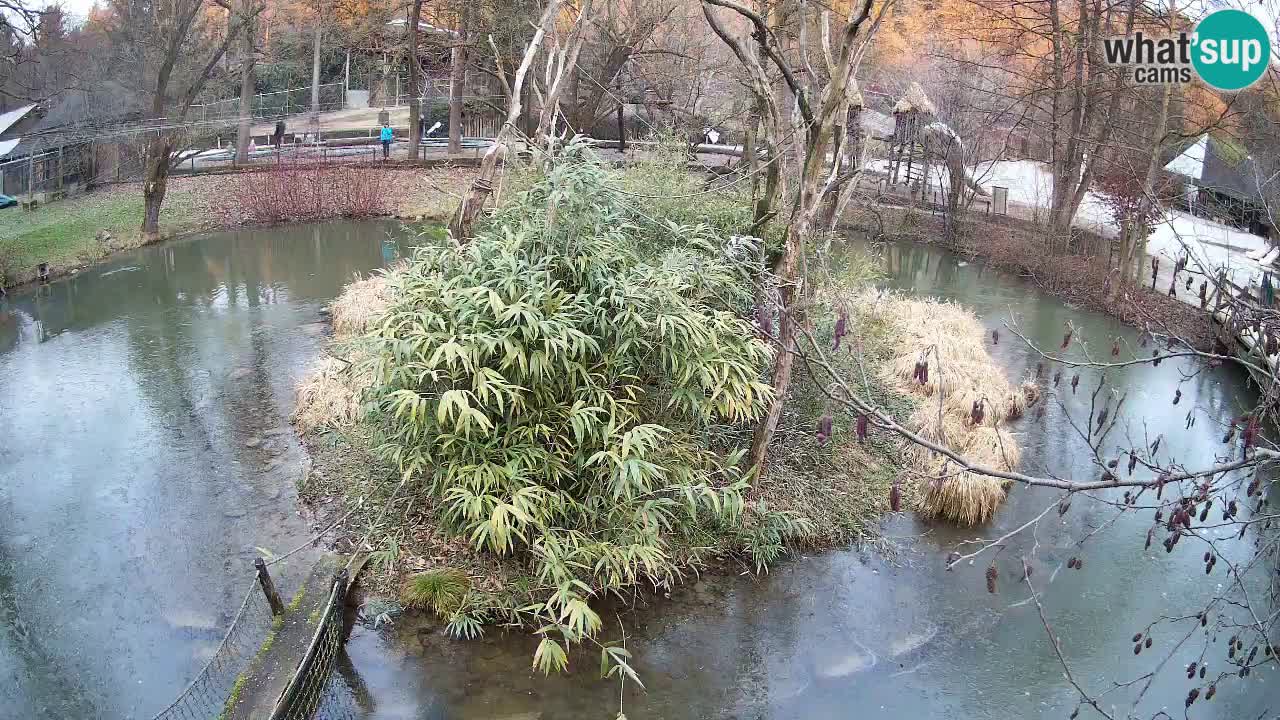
[0, 223, 417, 719]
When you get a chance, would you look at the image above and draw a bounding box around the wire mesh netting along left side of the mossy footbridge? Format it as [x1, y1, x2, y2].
[154, 578, 277, 720]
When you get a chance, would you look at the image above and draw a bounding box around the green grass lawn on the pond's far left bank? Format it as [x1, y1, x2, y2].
[0, 183, 197, 286]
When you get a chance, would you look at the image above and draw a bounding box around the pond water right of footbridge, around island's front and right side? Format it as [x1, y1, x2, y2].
[335, 238, 1280, 720]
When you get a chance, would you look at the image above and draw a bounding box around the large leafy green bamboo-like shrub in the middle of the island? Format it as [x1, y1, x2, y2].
[369, 145, 772, 671]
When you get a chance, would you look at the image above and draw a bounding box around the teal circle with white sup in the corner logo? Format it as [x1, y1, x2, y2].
[1192, 10, 1271, 90]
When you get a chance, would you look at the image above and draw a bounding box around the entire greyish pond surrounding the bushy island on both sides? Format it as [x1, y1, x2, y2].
[0, 223, 1280, 720]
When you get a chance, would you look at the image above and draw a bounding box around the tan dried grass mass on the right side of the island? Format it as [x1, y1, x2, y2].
[863, 288, 1039, 525]
